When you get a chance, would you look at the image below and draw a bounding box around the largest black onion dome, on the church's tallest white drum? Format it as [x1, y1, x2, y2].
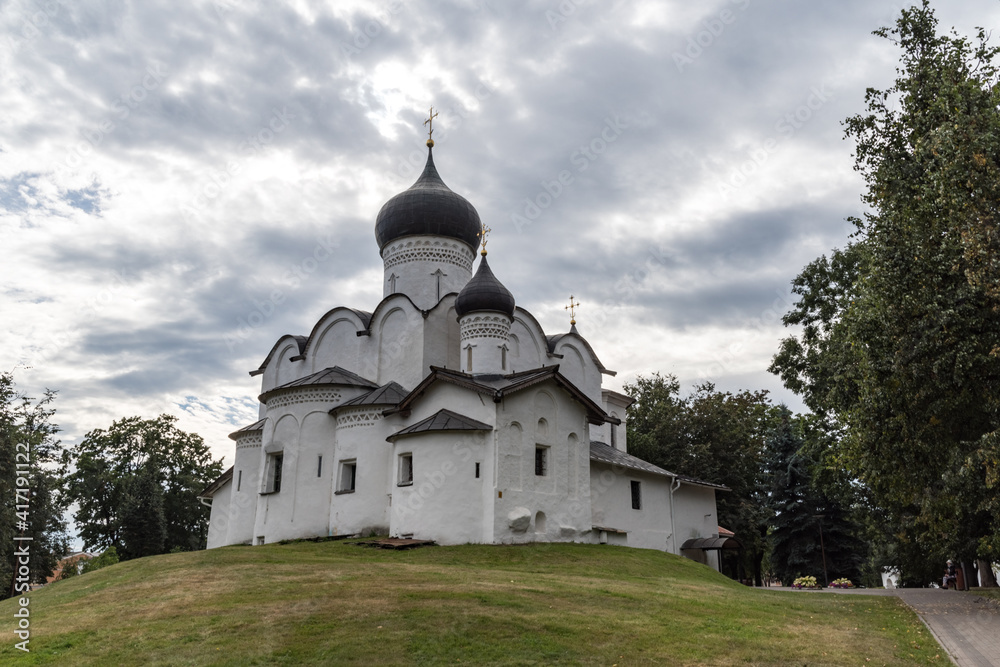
[375, 148, 482, 250]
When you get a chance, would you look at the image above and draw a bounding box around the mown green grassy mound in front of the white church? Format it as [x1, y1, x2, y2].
[0, 542, 948, 666]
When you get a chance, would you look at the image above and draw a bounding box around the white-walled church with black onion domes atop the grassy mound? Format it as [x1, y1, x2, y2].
[201, 141, 726, 568]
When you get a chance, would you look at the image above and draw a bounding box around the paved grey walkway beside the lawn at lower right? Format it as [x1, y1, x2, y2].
[768, 587, 1000, 667]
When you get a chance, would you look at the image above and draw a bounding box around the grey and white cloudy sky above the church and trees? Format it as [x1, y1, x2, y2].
[0, 0, 1000, 465]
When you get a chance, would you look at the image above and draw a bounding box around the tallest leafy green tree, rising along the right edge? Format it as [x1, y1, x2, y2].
[771, 0, 1000, 572]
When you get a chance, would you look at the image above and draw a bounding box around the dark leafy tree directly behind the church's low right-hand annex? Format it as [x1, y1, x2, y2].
[625, 373, 773, 585]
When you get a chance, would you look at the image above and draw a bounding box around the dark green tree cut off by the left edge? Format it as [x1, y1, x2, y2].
[0, 373, 69, 598]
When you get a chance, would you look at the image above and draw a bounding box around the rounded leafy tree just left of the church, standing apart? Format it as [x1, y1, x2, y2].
[63, 415, 222, 560]
